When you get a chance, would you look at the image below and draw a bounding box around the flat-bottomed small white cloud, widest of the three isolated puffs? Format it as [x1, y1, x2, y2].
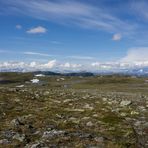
[27, 26, 47, 34]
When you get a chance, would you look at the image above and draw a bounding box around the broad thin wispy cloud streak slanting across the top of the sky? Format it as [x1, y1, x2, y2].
[2, 0, 135, 33]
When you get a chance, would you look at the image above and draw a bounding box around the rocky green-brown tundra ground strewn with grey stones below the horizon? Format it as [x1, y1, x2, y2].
[0, 73, 148, 148]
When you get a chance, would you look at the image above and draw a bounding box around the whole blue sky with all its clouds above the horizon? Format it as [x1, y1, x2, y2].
[0, 0, 148, 71]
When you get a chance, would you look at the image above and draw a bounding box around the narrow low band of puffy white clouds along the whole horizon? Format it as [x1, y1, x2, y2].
[0, 60, 148, 72]
